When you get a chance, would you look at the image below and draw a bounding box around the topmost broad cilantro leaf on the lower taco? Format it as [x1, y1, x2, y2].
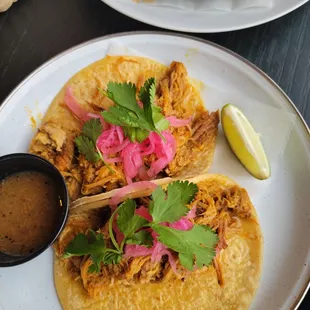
[149, 181, 198, 223]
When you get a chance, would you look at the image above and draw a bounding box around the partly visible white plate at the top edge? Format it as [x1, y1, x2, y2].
[102, 0, 308, 32]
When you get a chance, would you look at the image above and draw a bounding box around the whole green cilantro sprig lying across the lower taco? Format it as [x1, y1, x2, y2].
[64, 181, 218, 272]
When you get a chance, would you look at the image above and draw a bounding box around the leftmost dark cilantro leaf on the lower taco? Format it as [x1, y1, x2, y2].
[63, 230, 122, 272]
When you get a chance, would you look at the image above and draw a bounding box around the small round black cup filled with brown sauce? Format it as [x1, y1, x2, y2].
[0, 153, 69, 267]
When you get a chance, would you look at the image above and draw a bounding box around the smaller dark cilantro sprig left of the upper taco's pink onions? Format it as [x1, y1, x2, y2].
[74, 118, 114, 173]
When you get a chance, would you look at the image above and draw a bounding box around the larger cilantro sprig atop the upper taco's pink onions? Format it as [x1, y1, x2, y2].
[98, 78, 169, 142]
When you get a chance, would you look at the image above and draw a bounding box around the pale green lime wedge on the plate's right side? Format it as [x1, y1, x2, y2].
[221, 104, 270, 180]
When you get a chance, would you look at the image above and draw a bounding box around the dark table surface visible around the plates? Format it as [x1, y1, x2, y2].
[0, 0, 310, 310]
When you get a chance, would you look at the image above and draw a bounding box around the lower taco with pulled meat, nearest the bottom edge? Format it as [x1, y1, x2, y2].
[54, 175, 262, 310]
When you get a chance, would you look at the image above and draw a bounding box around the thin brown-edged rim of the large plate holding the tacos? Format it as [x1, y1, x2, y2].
[0, 30, 310, 310]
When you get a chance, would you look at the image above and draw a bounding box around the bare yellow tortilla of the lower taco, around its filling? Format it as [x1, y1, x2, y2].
[54, 175, 263, 310]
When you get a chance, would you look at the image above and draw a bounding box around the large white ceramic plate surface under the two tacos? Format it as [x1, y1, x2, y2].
[0, 33, 310, 310]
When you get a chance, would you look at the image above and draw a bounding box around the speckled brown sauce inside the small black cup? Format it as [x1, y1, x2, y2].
[0, 171, 62, 255]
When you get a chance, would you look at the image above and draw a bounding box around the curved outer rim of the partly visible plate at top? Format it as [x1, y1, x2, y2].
[101, 0, 309, 33]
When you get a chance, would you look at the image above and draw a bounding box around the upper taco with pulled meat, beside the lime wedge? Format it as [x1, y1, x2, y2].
[29, 56, 219, 200]
